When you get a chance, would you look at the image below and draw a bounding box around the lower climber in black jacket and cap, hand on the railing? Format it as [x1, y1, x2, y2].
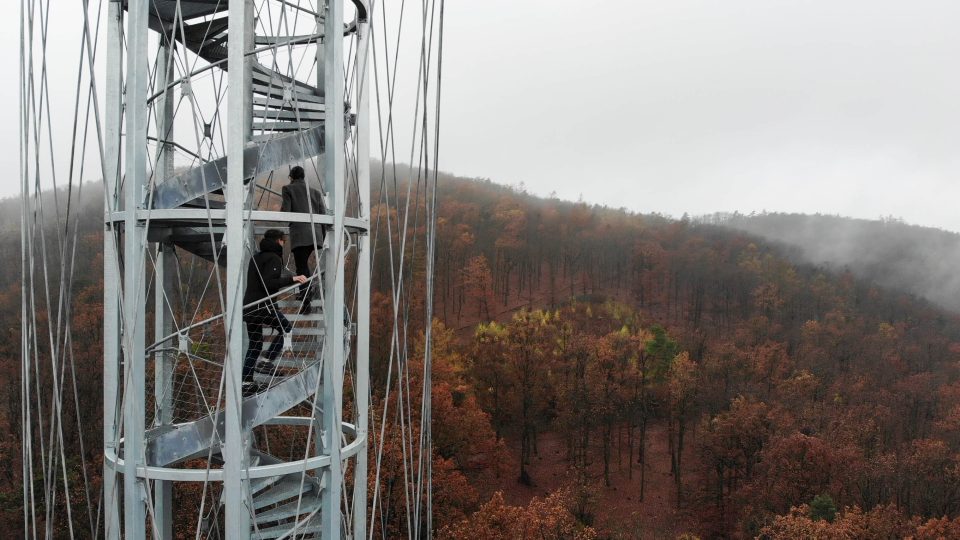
[243, 229, 307, 382]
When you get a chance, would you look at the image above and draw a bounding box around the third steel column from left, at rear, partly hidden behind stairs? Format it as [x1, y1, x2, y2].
[153, 36, 175, 540]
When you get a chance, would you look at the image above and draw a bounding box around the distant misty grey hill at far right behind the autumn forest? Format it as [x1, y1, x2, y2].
[703, 213, 960, 311]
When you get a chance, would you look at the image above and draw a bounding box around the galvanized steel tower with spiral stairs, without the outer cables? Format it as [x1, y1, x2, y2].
[103, 0, 371, 539]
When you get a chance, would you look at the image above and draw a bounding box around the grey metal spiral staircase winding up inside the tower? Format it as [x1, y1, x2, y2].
[131, 0, 350, 539]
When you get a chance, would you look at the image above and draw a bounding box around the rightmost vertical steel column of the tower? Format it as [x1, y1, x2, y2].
[353, 12, 370, 540]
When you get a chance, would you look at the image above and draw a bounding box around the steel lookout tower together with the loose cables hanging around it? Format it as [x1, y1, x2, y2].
[21, 0, 444, 539]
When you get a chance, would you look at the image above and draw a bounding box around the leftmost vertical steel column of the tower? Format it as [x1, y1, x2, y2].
[103, 0, 123, 540]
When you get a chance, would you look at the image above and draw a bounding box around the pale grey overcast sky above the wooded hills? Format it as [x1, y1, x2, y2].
[7, 0, 960, 231]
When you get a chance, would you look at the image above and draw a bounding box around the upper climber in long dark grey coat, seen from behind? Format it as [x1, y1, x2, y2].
[280, 165, 327, 313]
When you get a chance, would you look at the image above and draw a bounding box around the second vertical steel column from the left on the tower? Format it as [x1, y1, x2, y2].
[123, 0, 150, 540]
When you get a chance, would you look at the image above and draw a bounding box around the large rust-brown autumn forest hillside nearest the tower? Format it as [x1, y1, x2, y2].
[0, 171, 960, 539]
